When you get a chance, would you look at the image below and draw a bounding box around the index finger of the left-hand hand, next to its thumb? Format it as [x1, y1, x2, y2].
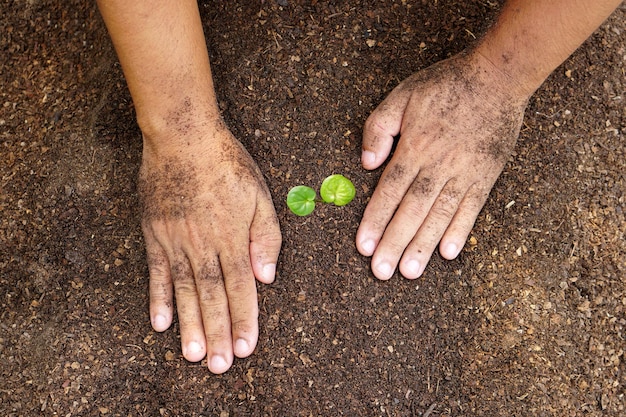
[220, 244, 259, 358]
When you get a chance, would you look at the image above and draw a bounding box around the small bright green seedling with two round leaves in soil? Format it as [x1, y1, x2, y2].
[287, 174, 356, 216]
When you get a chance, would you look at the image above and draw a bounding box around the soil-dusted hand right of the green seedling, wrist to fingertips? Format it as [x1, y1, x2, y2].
[356, 53, 528, 279]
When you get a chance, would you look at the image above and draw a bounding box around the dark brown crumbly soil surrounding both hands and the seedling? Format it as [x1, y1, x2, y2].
[0, 0, 626, 417]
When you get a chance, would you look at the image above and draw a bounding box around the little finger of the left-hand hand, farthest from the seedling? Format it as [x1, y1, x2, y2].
[144, 227, 174, 332]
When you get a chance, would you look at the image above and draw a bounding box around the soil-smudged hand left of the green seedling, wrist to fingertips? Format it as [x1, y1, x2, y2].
[138, 121, 281, 373]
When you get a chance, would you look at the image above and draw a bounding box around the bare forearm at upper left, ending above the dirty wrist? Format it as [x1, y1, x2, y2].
[98, 0, 219, 141]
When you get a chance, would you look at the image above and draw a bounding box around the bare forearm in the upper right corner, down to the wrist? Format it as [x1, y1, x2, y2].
[476, 0, 621, 95]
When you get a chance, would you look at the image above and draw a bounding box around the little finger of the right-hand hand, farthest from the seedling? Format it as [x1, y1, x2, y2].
[439, 184, 491, 259]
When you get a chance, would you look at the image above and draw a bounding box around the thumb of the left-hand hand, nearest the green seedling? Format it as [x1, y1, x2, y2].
[250, 194, 282, 284]
